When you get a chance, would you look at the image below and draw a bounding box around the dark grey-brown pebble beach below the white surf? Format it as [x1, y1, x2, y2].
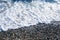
[0, 23, 60, 40]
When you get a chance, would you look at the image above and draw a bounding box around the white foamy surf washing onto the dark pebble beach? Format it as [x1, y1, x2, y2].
[0, 1, 60, 31]
